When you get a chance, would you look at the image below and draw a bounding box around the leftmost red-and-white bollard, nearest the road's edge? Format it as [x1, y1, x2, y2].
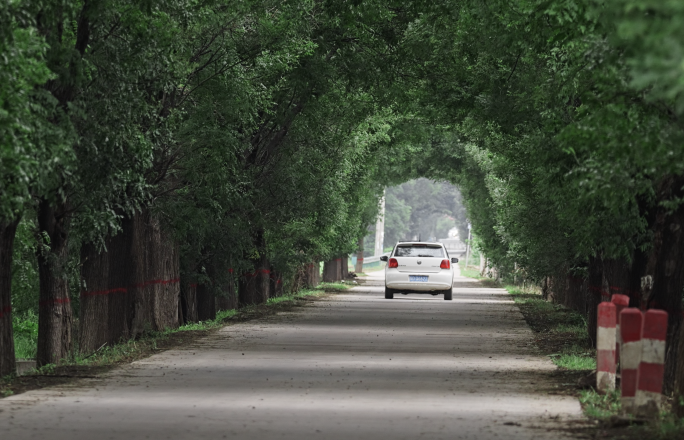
[596, 301, 617, 392]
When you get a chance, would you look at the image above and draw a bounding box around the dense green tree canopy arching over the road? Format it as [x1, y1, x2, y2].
[0, 0, 684, 412]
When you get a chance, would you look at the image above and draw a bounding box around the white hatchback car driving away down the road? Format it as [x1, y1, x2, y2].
[380, 242, 458, 300]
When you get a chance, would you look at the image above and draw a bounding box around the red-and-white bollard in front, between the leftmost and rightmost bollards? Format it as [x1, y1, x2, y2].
[619, 308, 643, 414]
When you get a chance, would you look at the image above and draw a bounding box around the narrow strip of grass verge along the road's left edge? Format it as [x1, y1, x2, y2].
[0, 285, 326, 397]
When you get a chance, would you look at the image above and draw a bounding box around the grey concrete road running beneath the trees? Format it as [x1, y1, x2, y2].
[0, 272, 581, 440]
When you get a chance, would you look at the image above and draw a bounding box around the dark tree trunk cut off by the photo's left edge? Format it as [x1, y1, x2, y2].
[0, 218, 19, 377]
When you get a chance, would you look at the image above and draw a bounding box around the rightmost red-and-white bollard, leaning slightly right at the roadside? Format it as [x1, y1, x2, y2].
[634, 309, 667, 416]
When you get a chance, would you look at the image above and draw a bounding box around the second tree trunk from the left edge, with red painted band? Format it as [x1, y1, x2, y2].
[36, 200, 72, 367]
